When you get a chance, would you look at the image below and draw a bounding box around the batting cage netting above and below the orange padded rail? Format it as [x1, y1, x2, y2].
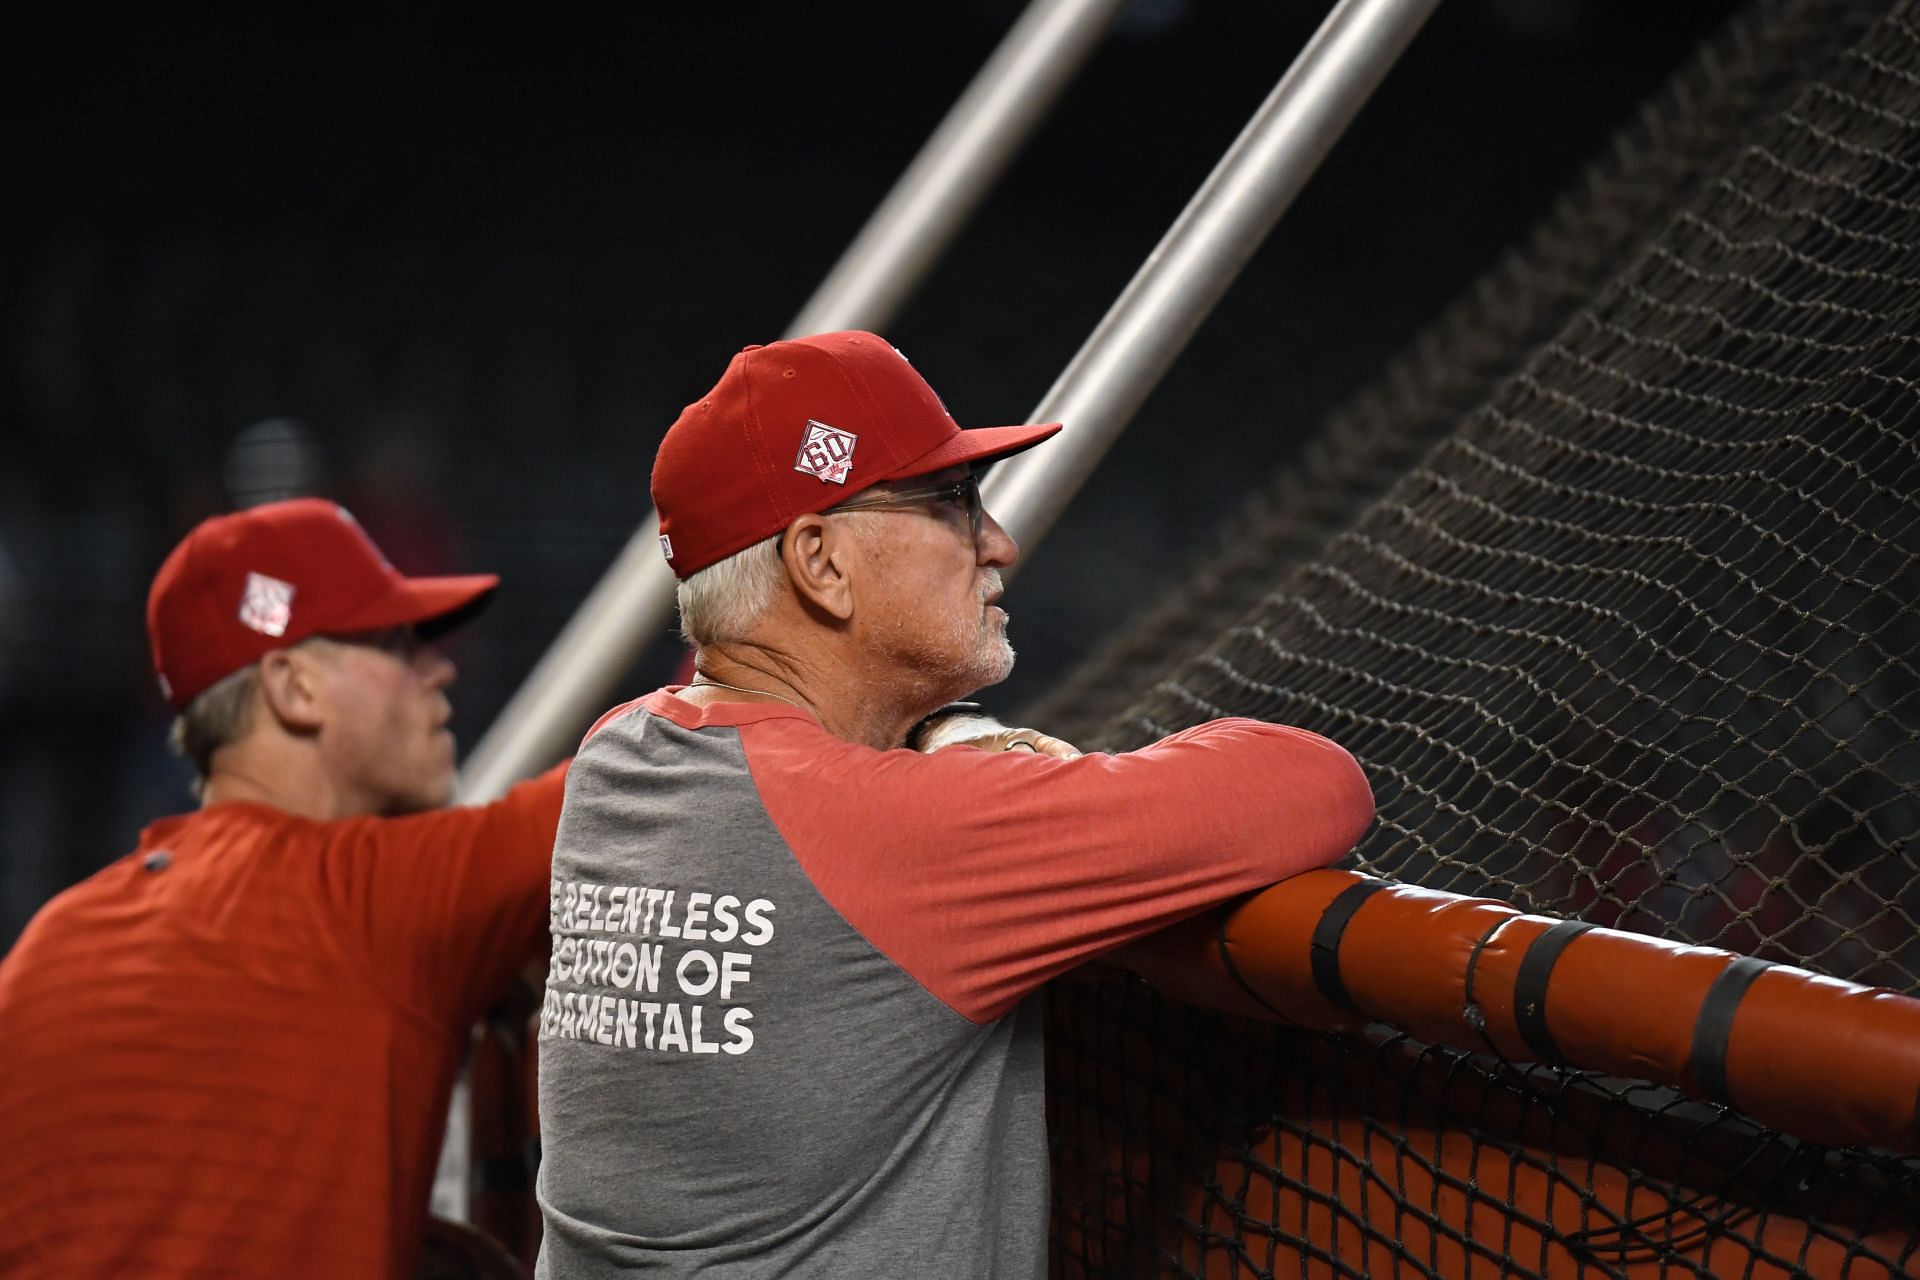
[1027, 2, 1920, 1280]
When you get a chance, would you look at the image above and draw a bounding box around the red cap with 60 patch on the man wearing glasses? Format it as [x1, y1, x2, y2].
[653, 332, 1060, 578]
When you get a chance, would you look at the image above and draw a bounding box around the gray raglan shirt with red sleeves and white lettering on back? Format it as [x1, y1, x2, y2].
[538, 689, 1373, 1280]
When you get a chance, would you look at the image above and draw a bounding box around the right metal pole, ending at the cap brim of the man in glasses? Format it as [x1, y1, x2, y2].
[983, 0, 1440, 568]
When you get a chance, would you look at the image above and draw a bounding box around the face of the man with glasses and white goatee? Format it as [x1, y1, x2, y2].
[845, 466, 1020, 702]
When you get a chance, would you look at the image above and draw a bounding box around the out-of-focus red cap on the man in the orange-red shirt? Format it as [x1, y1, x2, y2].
[146, 497, 499, 710]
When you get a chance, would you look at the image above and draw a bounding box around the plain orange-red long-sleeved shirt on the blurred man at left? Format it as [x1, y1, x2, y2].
[0, 770, 563, 1280]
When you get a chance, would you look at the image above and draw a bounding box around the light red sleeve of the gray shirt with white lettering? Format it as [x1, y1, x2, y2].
[741, 718, 1373, 1021]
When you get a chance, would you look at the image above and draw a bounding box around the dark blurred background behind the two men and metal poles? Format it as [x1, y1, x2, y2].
[0, 0, 1730, 940]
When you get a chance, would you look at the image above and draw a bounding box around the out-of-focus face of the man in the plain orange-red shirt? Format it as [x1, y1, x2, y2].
[319, 628, 453, 814]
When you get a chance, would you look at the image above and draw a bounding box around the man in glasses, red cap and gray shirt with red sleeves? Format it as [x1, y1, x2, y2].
[538, 334, 1373, 1280]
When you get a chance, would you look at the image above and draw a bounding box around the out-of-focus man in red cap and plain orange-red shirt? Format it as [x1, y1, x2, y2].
[0, 499, 561, 1280]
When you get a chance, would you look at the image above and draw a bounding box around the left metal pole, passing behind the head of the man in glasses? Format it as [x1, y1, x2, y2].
[459, 0, 1121, 804]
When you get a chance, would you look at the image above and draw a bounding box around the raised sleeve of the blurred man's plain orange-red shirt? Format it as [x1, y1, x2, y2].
[314, 764, 566, 1027]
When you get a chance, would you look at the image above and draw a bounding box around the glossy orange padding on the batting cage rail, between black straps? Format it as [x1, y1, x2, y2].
[1127, 871, 1920, 1153]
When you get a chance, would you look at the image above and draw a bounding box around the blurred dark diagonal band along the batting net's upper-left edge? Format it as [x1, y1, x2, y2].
[1027, 0, 1874, 741]
